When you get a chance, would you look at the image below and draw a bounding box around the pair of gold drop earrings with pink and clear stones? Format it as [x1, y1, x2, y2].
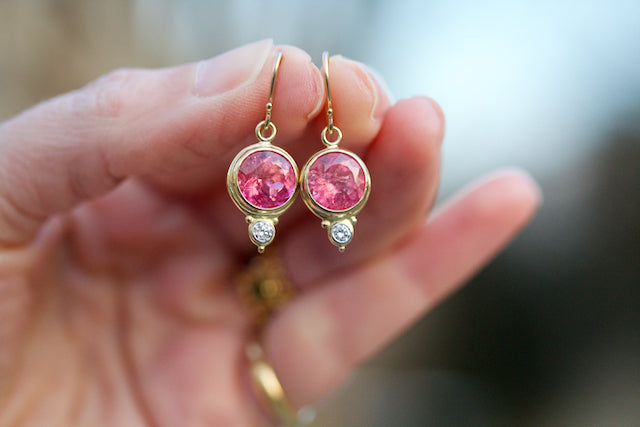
[227, 51, 371, 253]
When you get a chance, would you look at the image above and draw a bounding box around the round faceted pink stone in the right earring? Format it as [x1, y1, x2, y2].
[307, 152, 366, 211]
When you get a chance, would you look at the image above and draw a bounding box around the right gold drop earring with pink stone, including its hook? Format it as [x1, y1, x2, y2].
[300, 52, 371, 252]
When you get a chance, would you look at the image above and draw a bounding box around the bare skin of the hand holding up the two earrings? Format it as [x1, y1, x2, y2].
[0, 41, 540, 426]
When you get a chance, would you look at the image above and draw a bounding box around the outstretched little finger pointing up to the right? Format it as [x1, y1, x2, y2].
[264, 171, 539, 405]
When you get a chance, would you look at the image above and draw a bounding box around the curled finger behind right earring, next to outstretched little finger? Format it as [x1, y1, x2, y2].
[282, 98, 444, 287]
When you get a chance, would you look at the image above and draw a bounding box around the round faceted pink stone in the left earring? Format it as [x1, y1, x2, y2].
[238, 150, 296, 209]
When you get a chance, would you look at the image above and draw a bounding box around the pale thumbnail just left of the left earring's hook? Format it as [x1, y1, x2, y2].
[194, 40, 273, 96]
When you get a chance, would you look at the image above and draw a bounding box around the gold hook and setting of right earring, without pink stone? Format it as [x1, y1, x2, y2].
[300, 52, 371, 252]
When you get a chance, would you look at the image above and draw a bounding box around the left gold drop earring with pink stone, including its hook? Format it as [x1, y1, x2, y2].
[227, 51, 298, 253]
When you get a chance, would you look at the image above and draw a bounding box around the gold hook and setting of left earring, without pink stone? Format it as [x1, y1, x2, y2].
[227, 51, 300, 253]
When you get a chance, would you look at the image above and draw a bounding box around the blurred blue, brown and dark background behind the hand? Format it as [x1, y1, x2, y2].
[0, 0, 640, 426]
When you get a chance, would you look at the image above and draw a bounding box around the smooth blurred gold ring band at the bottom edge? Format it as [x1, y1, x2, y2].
[246, 342, 315, 427]
